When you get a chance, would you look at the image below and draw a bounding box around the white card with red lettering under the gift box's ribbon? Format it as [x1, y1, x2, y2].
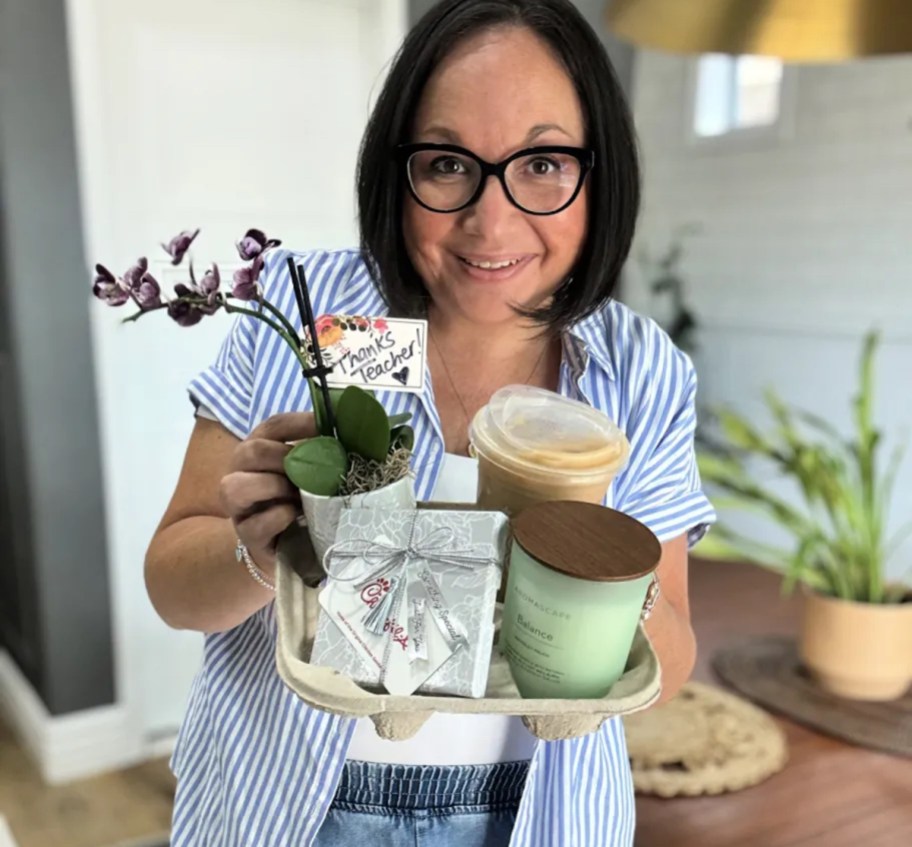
[319, 562, 453, 695]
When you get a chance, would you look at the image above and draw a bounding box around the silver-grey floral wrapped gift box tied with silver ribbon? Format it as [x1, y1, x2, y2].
[310, 509, 509, 697]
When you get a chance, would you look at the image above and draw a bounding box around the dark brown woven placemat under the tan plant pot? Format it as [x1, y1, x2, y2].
[713, 636, 912, 756]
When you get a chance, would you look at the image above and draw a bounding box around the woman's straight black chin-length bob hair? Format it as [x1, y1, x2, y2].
[357, 0, 640, 330]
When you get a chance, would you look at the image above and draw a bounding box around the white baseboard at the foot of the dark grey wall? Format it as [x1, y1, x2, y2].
[0, 650, 148, 785]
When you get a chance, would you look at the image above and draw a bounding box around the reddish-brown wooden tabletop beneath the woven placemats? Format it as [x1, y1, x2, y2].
[636, 561, 912, 847]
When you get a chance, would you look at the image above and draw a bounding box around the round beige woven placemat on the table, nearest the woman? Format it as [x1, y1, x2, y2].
[624, 682, 788, 797]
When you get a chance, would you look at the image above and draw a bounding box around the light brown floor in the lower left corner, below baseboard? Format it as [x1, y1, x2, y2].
[0, 723, 174, 847]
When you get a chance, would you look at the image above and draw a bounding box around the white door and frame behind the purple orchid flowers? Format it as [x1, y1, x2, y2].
[68, 0, 405, 756]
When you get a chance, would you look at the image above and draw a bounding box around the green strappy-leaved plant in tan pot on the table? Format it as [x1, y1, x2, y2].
[698, 332, 912, 700]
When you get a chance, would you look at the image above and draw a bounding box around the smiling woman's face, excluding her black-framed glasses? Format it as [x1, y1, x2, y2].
[403, 28, 587, 324]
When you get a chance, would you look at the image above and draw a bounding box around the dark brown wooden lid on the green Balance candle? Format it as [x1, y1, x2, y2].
[510, 500, 662, 582]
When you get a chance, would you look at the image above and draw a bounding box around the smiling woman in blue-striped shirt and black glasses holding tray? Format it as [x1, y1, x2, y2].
[146, 0, 712, 847]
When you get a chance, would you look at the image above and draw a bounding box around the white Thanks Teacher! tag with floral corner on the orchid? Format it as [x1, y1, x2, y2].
[305, 315, 427, 393]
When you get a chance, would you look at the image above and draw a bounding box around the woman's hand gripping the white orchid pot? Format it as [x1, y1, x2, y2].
[219, 412, 318, 576]
